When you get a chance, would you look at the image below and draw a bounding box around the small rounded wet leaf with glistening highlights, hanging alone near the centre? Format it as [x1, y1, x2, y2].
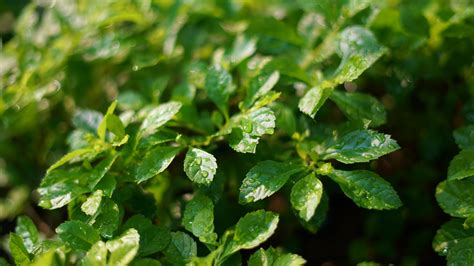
[184, 148, 217, 185]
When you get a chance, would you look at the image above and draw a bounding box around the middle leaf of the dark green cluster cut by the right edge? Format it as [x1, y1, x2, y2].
[436, 179, 474, 217]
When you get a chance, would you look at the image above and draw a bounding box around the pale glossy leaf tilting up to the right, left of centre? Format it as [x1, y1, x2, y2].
[140, 102, 181, 136]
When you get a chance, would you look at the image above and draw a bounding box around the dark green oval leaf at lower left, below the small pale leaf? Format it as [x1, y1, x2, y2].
[56, 221, 100, 251]
